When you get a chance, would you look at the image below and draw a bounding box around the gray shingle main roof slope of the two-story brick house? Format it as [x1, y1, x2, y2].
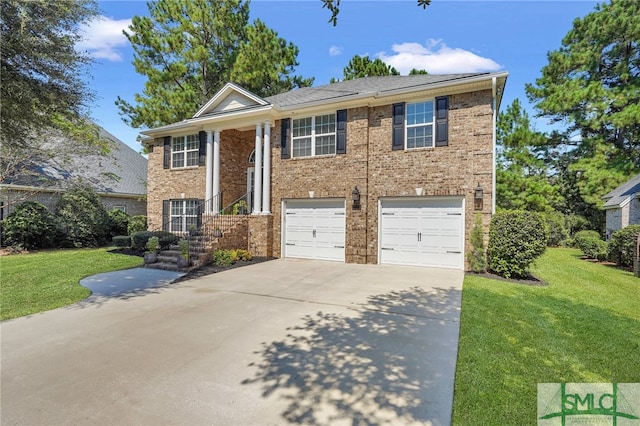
[265, 73, 489, 107]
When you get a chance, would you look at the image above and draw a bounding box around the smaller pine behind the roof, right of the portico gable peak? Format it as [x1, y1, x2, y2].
[231, 19, 313, 97]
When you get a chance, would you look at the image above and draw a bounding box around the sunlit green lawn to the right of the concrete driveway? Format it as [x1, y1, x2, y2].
[453, 248, 640, 425]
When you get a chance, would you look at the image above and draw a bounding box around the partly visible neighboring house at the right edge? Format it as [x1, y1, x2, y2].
[602, 175, 640, 240]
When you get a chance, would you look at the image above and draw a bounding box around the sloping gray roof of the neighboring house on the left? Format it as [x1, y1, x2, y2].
[2, 128, 147, 195]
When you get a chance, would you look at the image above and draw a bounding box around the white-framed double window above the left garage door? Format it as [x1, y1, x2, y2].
[291, 113, 336, 158]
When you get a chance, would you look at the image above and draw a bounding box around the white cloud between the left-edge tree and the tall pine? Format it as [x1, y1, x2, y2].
[76, 16, 131, 62]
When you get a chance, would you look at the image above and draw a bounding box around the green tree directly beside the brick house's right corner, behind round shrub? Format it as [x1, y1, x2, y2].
[496, 99, 563, 212]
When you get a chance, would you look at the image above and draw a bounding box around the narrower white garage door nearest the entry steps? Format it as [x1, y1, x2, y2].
[283, 200, 346, 262]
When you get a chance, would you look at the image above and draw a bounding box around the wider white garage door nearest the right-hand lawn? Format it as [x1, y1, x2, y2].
[380, 198, 464, 269]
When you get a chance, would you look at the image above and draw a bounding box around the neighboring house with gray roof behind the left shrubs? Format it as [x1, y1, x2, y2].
[0, 129, 147, 219]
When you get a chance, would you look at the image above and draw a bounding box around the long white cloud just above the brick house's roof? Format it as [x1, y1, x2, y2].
[376, 39, 502, 75]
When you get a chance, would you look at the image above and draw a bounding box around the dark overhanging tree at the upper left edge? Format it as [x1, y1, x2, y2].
[0, 0, 98, 148]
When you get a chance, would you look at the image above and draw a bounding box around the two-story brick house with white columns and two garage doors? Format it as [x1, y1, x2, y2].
[142, 72, 508, 269]
